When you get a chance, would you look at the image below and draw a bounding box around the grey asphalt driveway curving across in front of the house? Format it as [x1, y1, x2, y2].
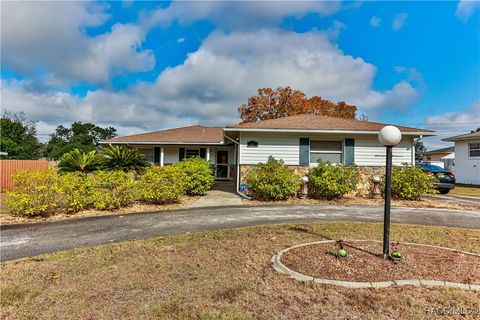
[0, 205, 480, 261]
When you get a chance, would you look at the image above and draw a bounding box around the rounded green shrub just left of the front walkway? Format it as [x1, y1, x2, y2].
[174, 157, 215, 195]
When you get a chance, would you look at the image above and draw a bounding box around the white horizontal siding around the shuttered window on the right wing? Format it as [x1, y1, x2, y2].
[240, 132, 414, 167]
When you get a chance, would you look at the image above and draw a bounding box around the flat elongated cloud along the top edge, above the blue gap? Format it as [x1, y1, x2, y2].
[143, 1, 342, 30]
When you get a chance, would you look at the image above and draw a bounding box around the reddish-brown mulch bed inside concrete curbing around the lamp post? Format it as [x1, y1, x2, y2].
[282, 241, 480, 284]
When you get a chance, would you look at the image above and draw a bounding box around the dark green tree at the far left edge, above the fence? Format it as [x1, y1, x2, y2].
[0, 112, 42, 160]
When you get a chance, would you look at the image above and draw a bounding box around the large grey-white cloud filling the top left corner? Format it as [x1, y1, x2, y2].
[1, 1, 155, 84]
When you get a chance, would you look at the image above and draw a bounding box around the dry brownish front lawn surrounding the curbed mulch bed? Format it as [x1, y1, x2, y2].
[0, 222, 480, 319]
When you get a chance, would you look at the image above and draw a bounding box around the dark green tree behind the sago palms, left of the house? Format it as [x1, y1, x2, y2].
[46, 122, 117, 159]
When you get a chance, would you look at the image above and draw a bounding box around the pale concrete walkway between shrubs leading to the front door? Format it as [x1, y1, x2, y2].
[188, 181, 242, 208]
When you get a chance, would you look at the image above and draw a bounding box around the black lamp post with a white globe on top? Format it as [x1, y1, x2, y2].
[378, 126, 402, 259]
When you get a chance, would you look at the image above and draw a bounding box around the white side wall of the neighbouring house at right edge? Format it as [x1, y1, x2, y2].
[455, 140, 480, 185]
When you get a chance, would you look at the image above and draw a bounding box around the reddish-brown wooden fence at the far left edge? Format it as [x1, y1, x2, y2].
[0, 160, 53, 191]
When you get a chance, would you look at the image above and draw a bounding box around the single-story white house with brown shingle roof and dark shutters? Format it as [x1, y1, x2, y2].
[101, 114, 435, 195]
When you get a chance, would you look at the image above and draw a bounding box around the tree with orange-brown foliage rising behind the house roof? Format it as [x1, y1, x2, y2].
[238, 87, 357, 122]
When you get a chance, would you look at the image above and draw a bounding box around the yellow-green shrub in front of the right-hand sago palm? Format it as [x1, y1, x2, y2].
[93, 171, 136, 210]
